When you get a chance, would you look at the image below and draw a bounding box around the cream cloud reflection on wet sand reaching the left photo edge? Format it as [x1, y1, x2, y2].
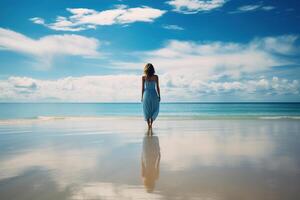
[0, 149, 103, 187]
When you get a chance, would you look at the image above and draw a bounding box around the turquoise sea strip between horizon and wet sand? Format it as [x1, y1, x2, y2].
[0, 103, 300, 119]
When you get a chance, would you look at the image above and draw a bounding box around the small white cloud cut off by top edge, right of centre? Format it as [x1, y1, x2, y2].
[167, 0, 227, 14]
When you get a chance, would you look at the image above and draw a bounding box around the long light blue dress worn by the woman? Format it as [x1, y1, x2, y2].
[143, 80, 159, 120]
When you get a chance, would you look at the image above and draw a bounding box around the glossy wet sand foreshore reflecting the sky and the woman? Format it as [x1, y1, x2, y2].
[0, 117, 300, 200]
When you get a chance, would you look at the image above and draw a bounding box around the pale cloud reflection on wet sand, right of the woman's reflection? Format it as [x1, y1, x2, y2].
[160, 133, 297, 170]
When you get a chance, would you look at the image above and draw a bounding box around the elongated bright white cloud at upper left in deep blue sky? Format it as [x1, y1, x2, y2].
[30, 5, 166, 31]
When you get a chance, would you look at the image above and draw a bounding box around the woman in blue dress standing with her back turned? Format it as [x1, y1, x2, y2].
[141, 63, 160, 129]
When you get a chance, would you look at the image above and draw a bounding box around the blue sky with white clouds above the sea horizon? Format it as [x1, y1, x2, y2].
[0, 0, 300, 102]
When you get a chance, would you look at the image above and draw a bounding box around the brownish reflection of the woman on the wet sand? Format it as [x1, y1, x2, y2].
[142, 135, 160, 192]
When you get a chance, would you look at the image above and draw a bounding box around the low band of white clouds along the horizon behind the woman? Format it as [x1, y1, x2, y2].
[0, 76, 300, 102]
